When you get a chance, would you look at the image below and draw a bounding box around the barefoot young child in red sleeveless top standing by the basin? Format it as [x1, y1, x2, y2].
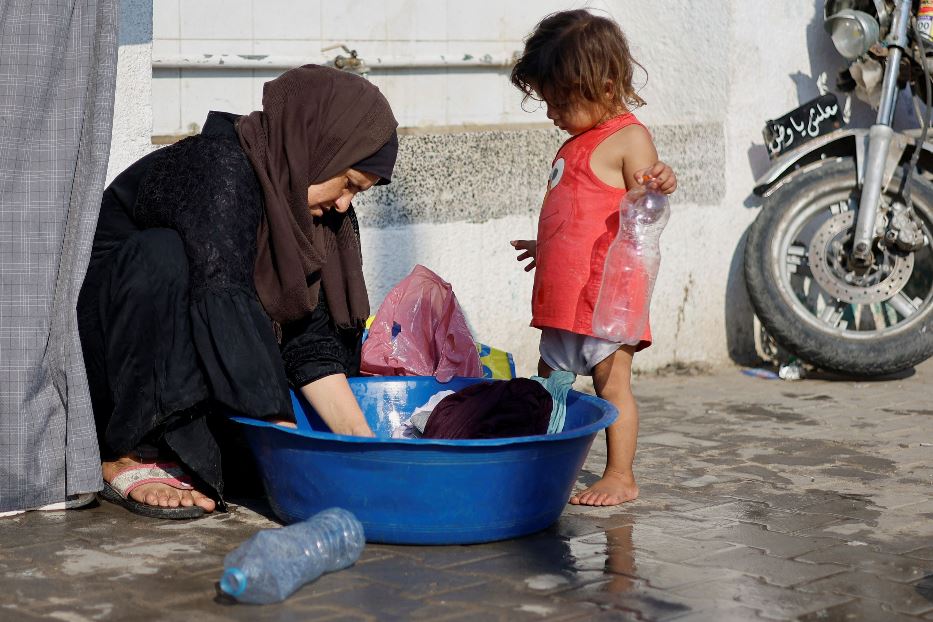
[511, 10, 677, 505]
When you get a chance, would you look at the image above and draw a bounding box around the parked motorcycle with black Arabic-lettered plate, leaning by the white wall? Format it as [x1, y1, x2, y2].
[744, 0, 933, 376]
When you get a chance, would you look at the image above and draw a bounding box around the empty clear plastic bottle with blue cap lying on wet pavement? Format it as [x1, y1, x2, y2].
[220, 508, 366, 605]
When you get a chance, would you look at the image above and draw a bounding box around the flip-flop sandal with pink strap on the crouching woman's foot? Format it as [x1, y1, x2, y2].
[100, 462, 204, 520]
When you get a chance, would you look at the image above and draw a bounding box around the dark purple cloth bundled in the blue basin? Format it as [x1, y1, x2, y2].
[422, 378, 553, 439]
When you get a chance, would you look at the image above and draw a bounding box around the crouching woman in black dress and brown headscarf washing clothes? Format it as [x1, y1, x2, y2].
[78, 65, 398, 518]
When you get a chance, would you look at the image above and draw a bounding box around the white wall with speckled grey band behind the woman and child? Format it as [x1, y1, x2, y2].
[137, 0, 865, 373]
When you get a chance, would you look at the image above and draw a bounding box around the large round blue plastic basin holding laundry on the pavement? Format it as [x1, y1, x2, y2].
[234, 377, 617, 544]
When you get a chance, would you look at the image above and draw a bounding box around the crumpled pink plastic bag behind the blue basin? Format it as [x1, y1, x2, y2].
[360, 265, 483, 382]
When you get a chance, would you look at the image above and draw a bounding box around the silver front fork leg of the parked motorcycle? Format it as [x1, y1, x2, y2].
[851, 0, 921, 267]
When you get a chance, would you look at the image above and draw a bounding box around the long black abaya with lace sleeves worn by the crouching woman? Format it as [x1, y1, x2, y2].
[78, 113, 359, 496]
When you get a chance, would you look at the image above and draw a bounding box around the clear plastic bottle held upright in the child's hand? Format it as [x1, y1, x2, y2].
[593, 176, 671, 345]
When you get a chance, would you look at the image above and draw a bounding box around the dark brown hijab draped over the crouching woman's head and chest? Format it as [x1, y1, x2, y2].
[237, 65, 398, 328]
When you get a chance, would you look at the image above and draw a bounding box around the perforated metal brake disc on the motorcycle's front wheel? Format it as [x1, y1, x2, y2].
[807, 211, 914, 304]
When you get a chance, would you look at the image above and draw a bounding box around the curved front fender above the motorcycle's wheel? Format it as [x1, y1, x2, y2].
[754, 128, 912, 197]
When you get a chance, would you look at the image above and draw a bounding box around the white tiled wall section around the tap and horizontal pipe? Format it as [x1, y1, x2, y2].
[153, 0, 566, 134]
